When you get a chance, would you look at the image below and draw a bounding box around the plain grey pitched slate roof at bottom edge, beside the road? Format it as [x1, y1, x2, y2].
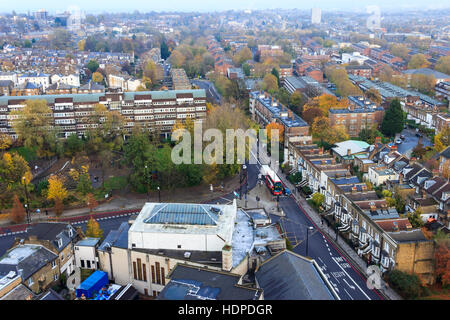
[255, 250, 336, 300]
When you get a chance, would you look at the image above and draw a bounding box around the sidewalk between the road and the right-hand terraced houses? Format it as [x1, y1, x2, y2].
[279, 174, 403, 300]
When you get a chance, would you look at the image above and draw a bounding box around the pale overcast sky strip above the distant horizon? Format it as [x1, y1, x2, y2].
[0, 0, 450, 13]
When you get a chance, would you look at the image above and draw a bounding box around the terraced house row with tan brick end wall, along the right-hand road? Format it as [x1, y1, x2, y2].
[288, 142, 435, 283]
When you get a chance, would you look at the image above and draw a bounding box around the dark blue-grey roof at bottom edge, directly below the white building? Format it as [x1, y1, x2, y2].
[157, 264, 262, 300]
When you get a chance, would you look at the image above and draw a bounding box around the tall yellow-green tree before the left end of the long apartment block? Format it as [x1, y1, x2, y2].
[12, 100, 56, 157]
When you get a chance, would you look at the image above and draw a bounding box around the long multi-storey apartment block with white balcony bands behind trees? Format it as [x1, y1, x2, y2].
[0, 89, 206, 138]
